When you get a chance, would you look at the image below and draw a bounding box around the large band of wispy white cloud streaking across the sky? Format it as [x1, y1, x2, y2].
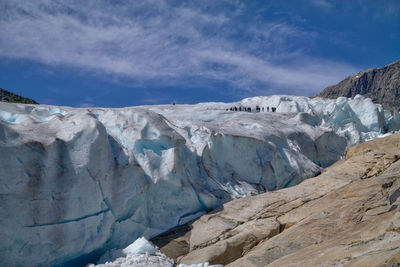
[0, 0, 355, 94]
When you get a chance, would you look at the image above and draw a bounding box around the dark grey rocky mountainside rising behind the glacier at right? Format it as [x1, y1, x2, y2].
[317, 60, 400, 110]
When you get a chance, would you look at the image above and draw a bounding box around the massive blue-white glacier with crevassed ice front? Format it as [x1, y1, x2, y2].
[0, 95, 400, 266]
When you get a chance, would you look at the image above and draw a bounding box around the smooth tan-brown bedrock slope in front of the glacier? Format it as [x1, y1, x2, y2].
[154, 133, 400, 266]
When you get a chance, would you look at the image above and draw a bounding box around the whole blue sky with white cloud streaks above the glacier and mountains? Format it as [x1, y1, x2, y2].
[0, 0, 400, 107]
